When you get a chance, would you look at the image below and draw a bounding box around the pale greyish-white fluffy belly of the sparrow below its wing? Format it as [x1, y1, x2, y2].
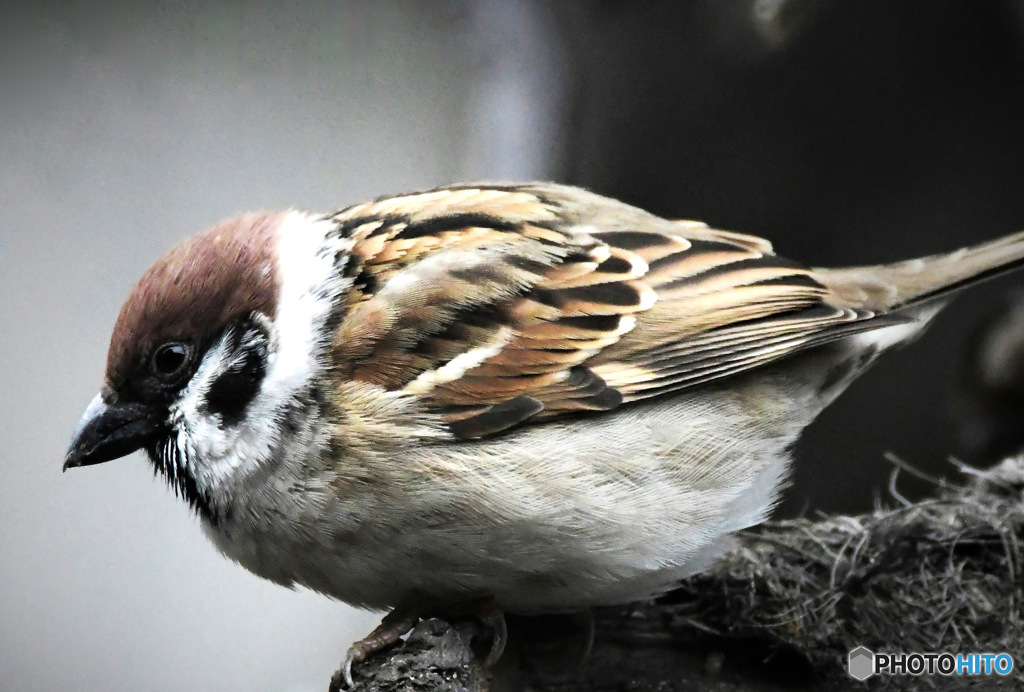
[205, 370, 809, 612]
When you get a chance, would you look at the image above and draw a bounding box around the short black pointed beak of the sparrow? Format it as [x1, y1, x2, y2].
[63, 394, 163, 471]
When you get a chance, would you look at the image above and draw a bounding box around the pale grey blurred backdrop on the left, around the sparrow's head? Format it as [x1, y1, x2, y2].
[0, 0, 560, 692]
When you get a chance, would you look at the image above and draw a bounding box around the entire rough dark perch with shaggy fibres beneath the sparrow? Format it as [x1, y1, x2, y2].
[356, 459, 1024, 692]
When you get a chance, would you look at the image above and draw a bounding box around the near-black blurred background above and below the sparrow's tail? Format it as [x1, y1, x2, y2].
[561, 0, 1024, 513]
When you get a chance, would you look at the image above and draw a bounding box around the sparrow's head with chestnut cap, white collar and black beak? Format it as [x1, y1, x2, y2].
[65, 211, 346, 515]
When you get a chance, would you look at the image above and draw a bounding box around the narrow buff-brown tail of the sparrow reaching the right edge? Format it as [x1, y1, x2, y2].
[818, 231, 1024, 313]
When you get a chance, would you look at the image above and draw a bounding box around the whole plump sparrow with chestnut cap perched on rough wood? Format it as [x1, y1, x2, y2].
[65, 183, 1024, 687]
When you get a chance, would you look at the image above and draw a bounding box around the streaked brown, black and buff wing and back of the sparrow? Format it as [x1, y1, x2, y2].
[334, 186, 897, 437]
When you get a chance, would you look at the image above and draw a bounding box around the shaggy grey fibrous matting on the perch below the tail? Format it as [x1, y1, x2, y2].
[651, 459, 1024, 689]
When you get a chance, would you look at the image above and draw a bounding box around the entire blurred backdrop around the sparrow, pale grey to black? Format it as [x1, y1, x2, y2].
[6, 0, 1024, 692]
